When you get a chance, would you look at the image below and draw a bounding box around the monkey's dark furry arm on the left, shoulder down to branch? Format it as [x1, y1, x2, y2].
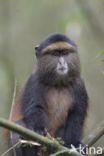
[22, 75, 48, 135]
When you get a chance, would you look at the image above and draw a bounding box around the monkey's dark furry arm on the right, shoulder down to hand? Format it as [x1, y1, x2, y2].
[64, 80, 88, 147]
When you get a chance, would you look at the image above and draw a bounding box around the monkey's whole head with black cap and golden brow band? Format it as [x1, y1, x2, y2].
[35, 34, 80, 84]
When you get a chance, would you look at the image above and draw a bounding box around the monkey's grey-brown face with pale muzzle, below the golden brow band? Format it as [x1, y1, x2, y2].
[38, 49, 80, 83]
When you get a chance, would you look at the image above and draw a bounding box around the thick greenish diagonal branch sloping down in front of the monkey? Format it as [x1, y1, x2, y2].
[0, 118, 81, 156]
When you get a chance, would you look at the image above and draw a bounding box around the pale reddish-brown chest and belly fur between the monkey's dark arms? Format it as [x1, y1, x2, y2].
[47, 88, 73, 137]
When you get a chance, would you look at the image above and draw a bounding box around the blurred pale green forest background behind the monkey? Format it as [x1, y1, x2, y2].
[0, 0, 104, 154]
